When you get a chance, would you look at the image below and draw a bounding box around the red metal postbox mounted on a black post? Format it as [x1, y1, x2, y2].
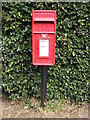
[32, 10, 56, 65]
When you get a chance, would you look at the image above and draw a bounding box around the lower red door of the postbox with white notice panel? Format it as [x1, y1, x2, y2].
[33, 34, 55, 65]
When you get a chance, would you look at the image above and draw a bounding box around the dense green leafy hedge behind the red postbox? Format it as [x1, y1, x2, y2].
[2, 2, 90, 101]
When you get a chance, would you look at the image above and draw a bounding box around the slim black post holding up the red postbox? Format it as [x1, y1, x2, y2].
[41, 66, 47, 108]
